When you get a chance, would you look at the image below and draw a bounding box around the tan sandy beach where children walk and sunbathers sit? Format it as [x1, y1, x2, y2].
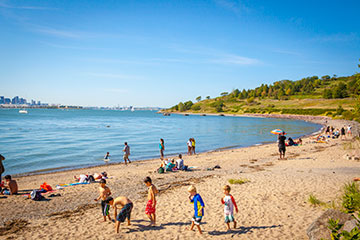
[0, 116, 360, 239]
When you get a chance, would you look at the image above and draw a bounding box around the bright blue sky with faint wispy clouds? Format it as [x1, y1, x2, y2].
[0, 0, 360, 107]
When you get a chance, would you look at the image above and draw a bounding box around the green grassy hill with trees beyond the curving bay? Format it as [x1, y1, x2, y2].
[166, 66, 360, 121]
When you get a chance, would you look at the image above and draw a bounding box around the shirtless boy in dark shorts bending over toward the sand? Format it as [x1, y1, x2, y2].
[109, 197, 134, 233]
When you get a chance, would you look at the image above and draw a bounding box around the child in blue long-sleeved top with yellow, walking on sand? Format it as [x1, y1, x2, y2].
[188, 185, 205, 234]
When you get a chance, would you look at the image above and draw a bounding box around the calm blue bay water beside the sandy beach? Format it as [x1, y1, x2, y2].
[0, 109, 321, 174]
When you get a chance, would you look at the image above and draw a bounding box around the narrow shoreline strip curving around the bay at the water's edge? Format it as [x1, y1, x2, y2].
[12, 112, 331, 178]
